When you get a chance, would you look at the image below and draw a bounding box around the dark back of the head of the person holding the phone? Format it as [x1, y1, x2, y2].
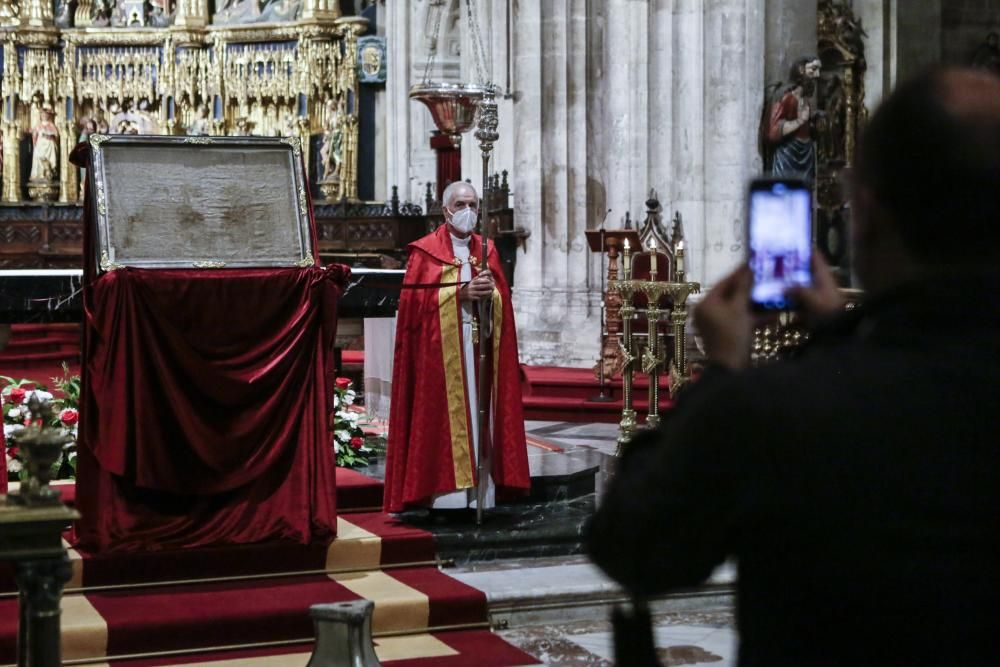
[855, 68, 1000, 266]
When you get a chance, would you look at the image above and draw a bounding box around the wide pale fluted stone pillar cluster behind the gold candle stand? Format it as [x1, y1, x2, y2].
[501, 0, 772, 366]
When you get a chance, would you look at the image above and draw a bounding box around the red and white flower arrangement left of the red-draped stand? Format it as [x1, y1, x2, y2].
[0, 364, 80, 479]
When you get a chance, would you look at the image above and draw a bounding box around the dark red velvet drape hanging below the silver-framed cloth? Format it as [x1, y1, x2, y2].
[77, 266, 349, 550]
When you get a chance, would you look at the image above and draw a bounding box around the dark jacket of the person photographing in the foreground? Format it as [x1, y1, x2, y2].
[589, 275, 1000, 666]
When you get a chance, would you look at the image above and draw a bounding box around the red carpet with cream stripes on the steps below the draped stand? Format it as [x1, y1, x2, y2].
[0, 513, 535, 665]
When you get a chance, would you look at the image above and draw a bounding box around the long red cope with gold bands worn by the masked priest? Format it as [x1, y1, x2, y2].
[385, 225, 530, 512]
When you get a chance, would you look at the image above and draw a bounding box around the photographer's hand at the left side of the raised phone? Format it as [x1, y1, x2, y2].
[694, 266, 753, 370]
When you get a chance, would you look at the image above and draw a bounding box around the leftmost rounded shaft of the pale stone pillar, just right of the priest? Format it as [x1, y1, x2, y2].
[514, 0, 600, 365]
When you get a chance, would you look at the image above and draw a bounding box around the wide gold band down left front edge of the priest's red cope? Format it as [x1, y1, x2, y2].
[438, 264, 473, 489]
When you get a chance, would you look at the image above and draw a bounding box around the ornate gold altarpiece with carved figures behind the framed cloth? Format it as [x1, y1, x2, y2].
[0, 0, 368, 204]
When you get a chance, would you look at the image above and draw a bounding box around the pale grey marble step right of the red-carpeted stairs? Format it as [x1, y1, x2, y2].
[447, 556, 736, 628]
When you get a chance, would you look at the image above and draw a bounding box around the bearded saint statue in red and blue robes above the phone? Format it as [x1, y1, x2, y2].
[760, 56, 820, 183]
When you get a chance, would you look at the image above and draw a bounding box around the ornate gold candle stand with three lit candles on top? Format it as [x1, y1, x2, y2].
[609, 240, 701, 452]
